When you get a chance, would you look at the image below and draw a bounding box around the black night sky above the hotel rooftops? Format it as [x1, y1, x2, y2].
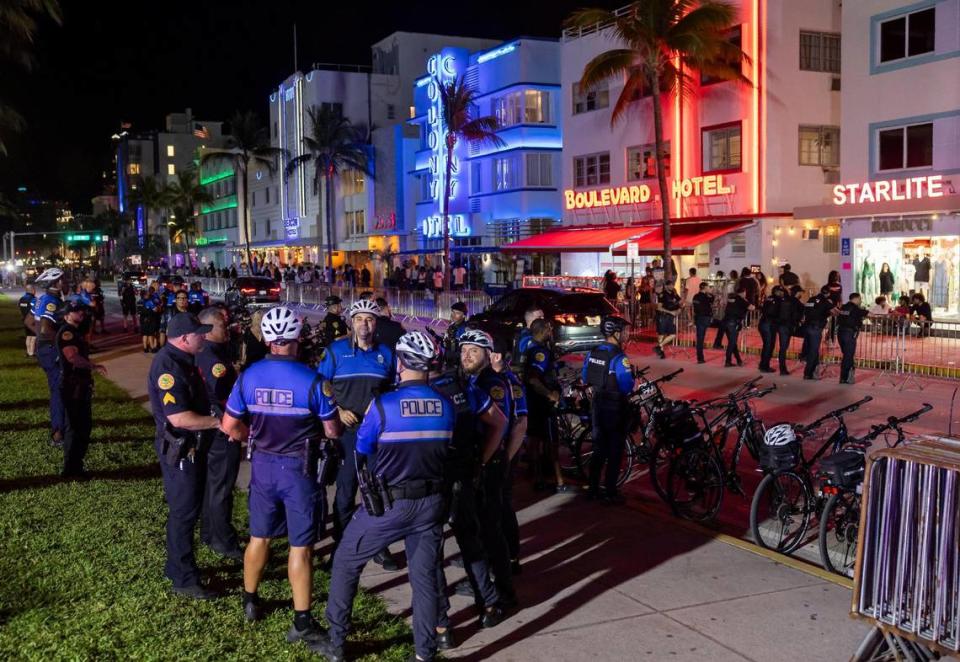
[0, 0, 625, 213]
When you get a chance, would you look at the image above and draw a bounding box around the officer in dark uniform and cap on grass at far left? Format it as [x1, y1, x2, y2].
[55, 301, 107, 478]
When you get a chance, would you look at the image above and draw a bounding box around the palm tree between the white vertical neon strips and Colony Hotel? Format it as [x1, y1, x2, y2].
[286, 106, 374, 268]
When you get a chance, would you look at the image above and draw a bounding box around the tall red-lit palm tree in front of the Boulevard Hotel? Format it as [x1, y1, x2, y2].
[567, 0, 748, 276]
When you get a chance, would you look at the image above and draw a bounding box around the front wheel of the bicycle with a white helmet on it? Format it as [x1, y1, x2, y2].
[750, 471, 813, 554]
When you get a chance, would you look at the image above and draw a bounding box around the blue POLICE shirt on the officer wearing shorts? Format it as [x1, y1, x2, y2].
[226, 354, 337, 455]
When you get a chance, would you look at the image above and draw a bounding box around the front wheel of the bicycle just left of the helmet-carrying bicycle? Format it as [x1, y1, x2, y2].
[667, 445, 723, 522]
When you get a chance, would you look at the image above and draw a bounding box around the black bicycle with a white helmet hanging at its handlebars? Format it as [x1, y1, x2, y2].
[750, 395, 873, 554]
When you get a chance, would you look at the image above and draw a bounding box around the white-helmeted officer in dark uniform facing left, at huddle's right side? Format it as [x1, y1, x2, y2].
[460, 329, 517, 606]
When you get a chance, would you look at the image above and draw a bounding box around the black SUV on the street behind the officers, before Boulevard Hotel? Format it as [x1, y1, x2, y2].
[469, 287, 617, 354]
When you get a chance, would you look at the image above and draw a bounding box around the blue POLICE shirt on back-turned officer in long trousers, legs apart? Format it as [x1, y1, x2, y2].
[357, 381, 456, 486]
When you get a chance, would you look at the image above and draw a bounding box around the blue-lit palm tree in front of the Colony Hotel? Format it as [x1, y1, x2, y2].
[434, 76, 506, 289]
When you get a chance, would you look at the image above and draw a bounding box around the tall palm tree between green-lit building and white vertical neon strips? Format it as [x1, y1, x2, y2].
[200, 110, 284, 267]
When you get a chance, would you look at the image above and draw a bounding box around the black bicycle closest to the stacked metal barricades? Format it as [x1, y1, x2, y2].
[819, 404, 933, 577]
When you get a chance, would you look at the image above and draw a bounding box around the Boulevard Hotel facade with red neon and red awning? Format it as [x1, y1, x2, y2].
[507, 0, 841, 286]
